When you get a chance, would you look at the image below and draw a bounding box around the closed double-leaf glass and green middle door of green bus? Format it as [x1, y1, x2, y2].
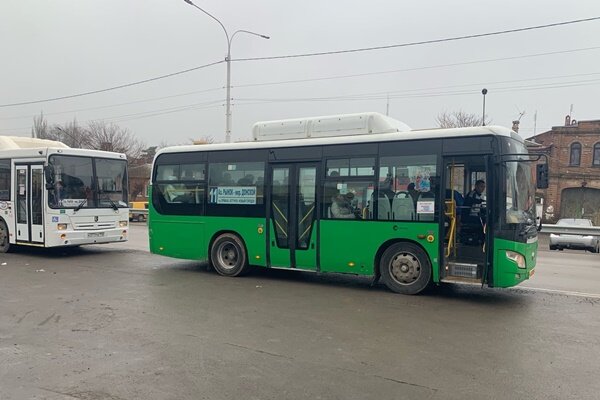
[267, 163, 317, 270]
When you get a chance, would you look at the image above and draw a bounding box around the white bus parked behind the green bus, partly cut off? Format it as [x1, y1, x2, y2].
[0, 136, 129, 253]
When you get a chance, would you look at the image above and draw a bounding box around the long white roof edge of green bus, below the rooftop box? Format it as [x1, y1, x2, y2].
[156, 125, 522, 156]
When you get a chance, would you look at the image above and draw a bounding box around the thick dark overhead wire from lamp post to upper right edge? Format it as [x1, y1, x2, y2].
[231, 17, 600, 61]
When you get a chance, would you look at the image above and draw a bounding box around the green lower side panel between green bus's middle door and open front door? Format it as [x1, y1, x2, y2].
[320, 220, 439, 282]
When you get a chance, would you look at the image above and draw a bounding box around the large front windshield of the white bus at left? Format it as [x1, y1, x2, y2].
[48, 155, 127, 209]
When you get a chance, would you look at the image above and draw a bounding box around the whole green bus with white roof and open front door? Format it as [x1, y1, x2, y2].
[149, 113, 547, 294]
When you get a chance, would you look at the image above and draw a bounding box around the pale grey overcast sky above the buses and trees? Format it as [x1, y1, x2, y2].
[0, 0, 600, 146]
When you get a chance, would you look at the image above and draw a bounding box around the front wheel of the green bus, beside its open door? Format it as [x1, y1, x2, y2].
[379, 243, 431, 294]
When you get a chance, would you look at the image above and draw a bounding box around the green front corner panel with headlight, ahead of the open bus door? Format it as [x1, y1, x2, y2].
[494, 239, 538, 287]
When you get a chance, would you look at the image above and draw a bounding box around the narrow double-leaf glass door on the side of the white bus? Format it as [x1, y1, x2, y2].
[15, 164, 44, 243]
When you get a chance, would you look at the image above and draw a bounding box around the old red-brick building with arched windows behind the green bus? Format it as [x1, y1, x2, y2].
[527, 116, 600, 226]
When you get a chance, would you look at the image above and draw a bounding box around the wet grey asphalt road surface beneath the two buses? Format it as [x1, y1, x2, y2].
[0, 225, 600, 400]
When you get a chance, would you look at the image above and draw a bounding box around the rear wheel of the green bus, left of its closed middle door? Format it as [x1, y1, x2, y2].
[210, 233, 249, 276]
